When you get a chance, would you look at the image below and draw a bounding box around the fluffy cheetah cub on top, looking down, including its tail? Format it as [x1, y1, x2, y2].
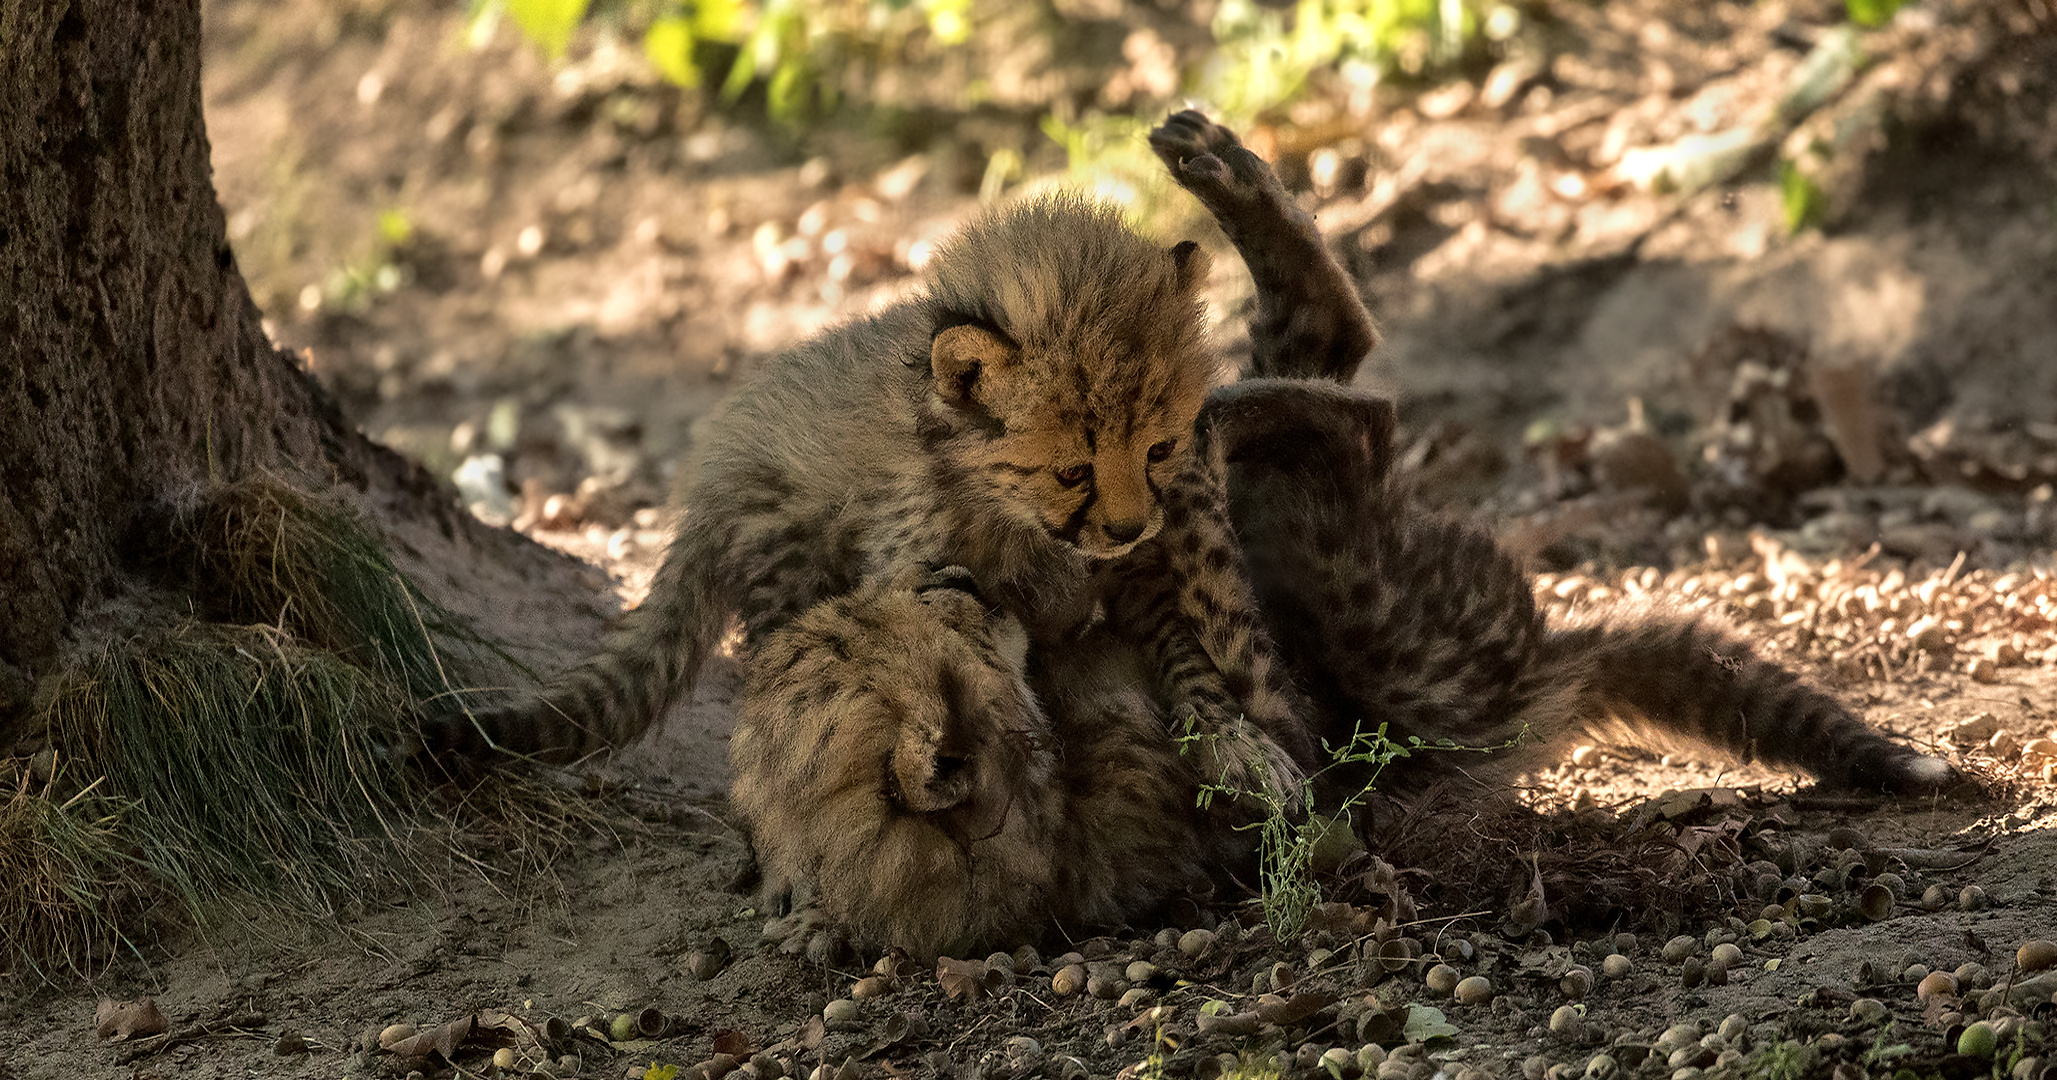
[424, 197, 1275, 757]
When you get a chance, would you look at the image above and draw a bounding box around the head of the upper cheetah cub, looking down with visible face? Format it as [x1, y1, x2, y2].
[928, 200, 1220, 560]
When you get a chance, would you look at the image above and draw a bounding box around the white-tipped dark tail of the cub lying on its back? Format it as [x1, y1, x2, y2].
[1539, 613, 1958, 794]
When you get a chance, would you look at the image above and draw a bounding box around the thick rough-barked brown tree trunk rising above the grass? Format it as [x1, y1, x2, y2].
[0, 0, 594, 749]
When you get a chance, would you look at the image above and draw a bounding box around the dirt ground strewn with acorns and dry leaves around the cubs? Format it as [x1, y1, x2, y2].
[0, 0, 2057, 1080]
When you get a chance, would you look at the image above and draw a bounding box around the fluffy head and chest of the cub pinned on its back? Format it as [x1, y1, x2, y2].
[730, 582, 1249, 957]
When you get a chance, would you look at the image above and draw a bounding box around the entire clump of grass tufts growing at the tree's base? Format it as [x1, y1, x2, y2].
[0, 477, 506, 971]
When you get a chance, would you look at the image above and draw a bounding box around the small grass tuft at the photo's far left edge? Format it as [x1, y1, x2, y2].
[0, 757, 134, 981]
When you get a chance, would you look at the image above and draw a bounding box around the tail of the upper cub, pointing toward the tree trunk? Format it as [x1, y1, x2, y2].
[422, 518, 734, 761]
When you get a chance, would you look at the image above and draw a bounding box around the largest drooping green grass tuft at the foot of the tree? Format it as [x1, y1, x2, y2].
[45, 623, 405, 917]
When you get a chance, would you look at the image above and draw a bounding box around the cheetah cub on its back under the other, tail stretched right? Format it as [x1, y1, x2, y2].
[732, 379, 1954, 955]
